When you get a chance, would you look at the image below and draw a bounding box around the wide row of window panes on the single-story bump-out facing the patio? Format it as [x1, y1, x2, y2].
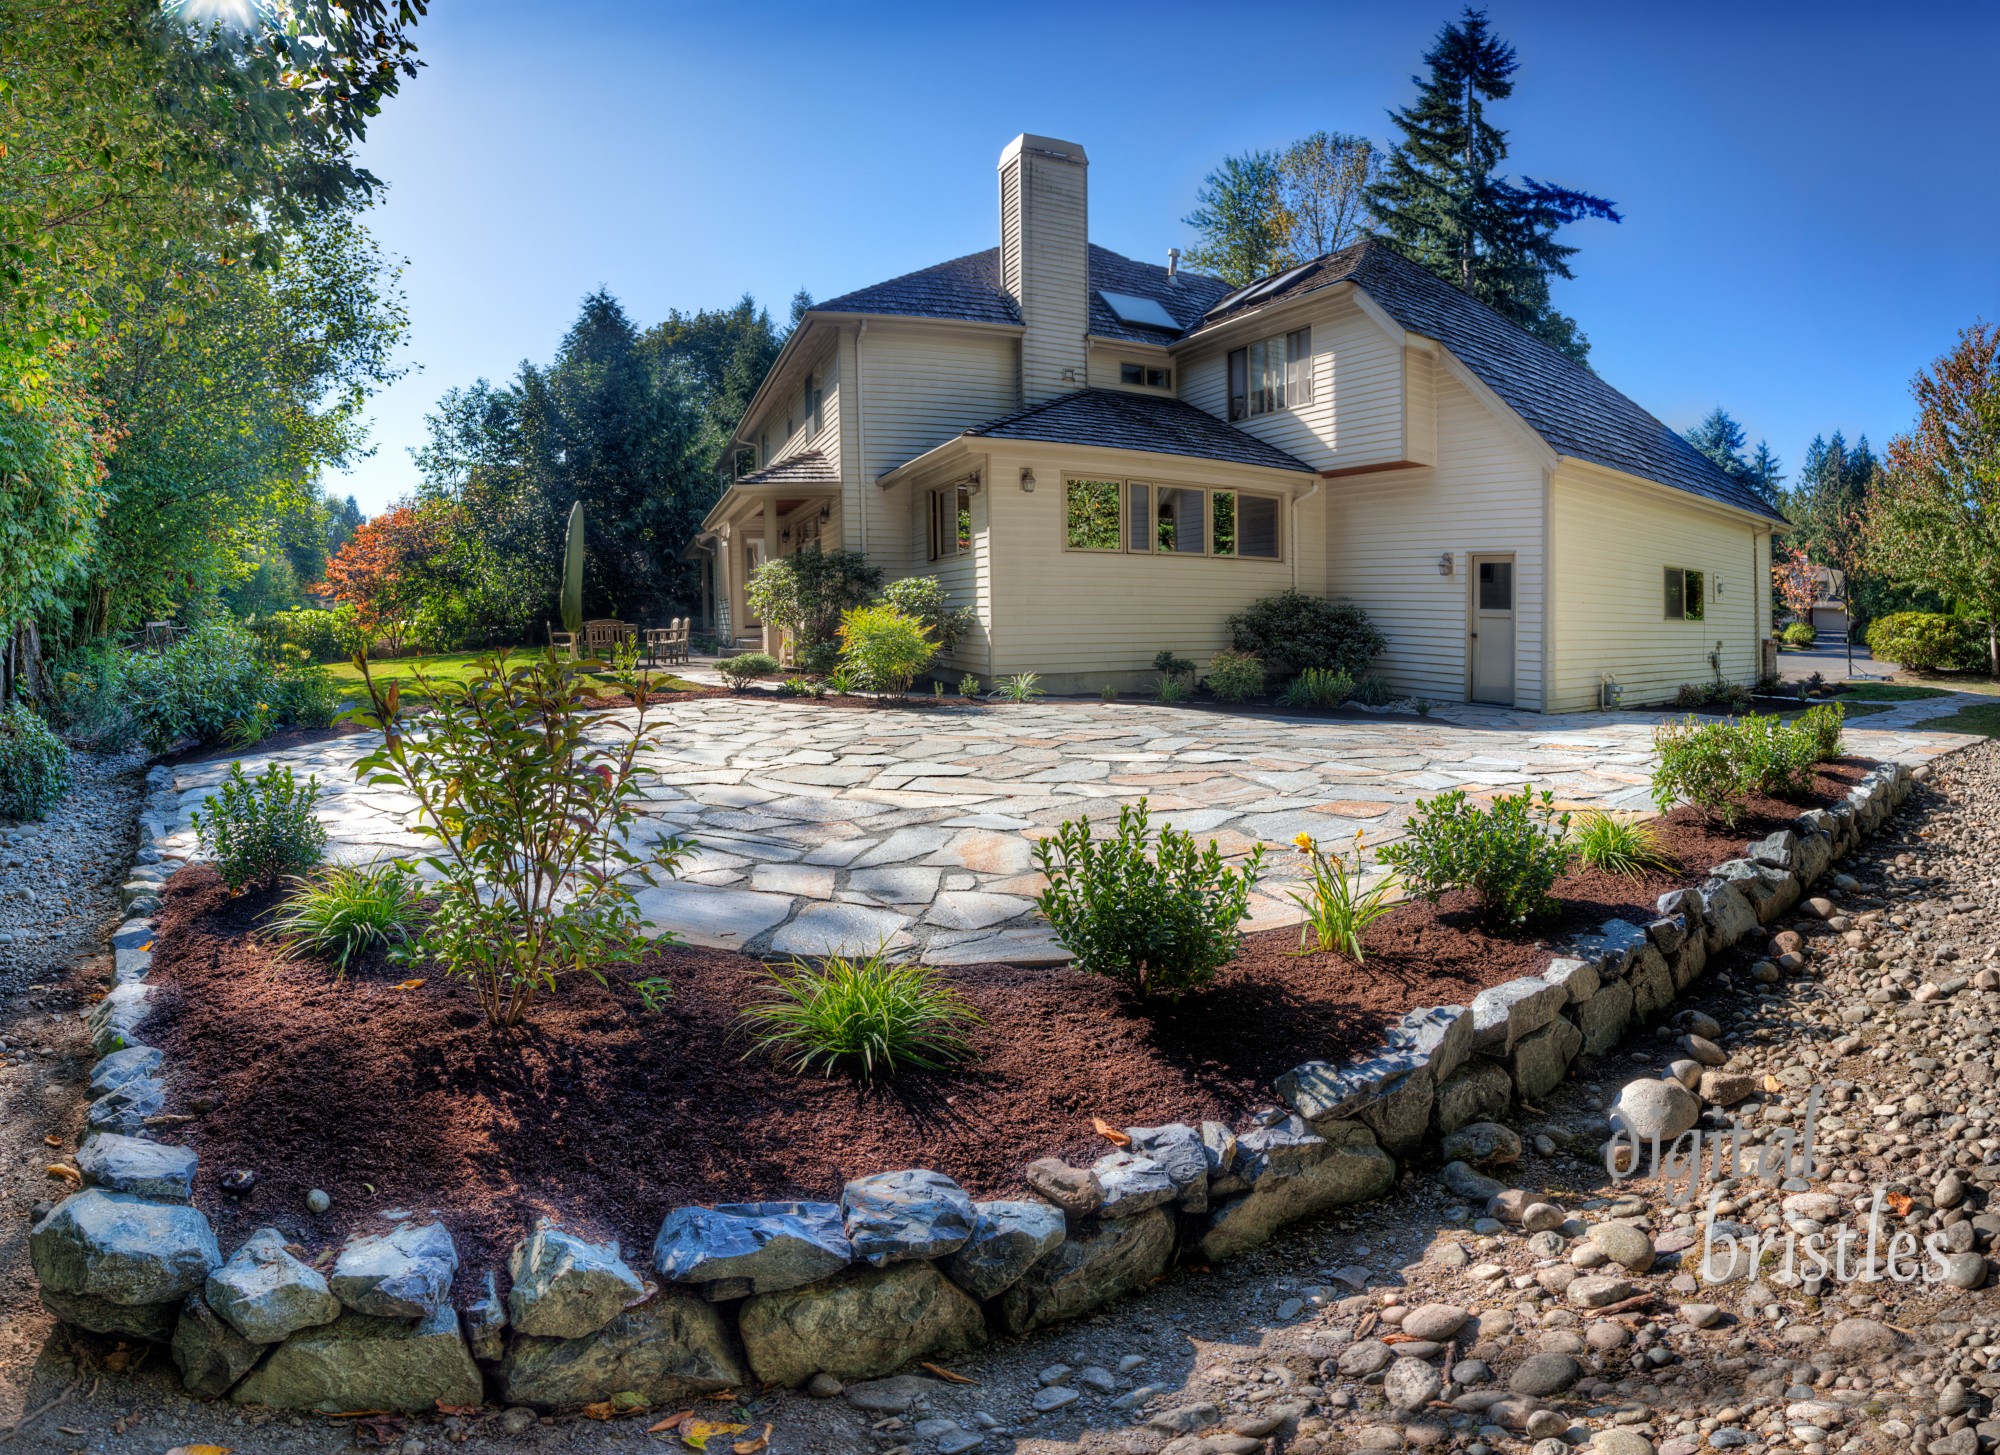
[1062, 476, 1284, 562]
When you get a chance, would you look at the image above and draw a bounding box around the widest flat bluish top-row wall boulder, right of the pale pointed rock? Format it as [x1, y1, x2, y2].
[652, 1203, 854, 1293]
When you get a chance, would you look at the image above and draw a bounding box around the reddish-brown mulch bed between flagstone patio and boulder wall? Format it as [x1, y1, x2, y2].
[146, 759, 1868, 1269]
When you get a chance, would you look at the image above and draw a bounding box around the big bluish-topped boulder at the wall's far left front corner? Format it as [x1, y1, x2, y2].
[28, 1187, 222, 1305]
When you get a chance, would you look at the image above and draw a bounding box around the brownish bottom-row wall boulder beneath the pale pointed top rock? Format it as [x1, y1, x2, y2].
[496, 1289, 750, 1409]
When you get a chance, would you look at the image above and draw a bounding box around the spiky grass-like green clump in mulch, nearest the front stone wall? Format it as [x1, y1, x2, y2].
[742, 949, 984, 1081]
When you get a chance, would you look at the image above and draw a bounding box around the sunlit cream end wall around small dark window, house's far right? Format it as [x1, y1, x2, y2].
[1552, 462, 1770, 712]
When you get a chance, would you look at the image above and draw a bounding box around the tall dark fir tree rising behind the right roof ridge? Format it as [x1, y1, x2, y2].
[1368, 8, 1620, 364]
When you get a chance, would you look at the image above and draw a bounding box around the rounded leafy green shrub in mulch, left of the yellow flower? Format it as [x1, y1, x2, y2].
[1034, 799, 1264, 999]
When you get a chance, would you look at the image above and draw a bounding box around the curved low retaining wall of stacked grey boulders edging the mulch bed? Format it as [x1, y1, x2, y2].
[30, 765, 1922, 1411]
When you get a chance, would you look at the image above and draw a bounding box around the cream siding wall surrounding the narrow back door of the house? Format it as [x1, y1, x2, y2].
[1326, 370, 1544, 708]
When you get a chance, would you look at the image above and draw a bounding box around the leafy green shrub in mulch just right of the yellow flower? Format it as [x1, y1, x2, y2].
[1382, 787, 1576, 929]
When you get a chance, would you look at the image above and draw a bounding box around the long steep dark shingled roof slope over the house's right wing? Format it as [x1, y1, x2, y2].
[1204, 240, 1784, 522]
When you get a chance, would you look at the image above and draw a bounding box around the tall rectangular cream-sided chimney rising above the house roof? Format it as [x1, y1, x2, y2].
[1000, 134, 1090, 406]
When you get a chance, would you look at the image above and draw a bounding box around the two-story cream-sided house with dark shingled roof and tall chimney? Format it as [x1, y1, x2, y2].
[698, 136, 1782, 712]
